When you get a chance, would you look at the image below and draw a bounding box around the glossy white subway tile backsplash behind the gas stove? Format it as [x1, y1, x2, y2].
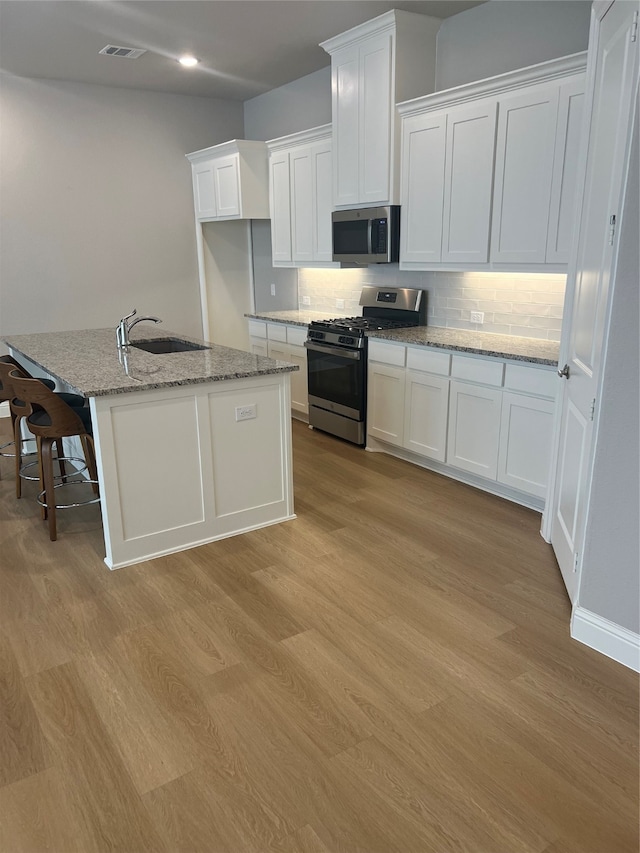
[298, 264, 566, 341]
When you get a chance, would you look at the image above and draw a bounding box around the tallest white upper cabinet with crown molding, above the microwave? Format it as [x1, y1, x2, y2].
[320, 10, 441, 208]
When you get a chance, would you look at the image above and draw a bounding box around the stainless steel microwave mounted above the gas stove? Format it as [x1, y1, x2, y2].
[331, 205, 400, 265]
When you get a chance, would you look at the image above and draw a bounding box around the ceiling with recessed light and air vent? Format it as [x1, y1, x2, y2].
[0, 0, 483, 100]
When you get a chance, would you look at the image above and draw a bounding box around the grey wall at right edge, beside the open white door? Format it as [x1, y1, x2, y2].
[578, 103, 640, 634]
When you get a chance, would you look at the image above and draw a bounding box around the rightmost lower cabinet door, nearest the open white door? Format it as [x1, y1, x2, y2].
[498, 392, 554, 498]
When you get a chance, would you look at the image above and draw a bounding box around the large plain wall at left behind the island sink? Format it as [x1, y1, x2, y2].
[0, 75, 243, 336]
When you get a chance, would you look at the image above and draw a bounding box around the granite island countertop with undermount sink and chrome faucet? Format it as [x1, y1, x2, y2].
[2, 324, 299, 397]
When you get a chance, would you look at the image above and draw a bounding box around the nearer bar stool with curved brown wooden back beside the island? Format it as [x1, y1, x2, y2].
[9, 370, 100, 542]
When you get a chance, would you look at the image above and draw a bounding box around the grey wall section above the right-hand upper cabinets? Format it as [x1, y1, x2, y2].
[436, 0, 591, 90]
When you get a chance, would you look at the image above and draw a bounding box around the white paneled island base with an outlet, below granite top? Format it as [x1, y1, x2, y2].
[90, 373, 295, 569]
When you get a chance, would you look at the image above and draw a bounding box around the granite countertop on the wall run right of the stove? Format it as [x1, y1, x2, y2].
[368, 326, 560, 366]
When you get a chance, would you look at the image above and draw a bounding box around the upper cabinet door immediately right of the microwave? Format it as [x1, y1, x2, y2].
[400, 113, 447, 263]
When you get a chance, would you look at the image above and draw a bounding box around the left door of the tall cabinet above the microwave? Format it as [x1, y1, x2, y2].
[331, 44, 360, 206]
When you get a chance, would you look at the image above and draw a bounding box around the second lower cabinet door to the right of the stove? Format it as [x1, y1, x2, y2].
[404, 370, 449, 462]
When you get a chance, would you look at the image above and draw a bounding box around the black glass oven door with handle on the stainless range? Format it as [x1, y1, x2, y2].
[305, 341, 367, 421]
